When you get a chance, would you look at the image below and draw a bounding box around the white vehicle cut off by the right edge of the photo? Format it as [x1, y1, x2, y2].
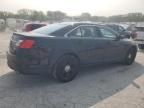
[134, 25, 144, 49]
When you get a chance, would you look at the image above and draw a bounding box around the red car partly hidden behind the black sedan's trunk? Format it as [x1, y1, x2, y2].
[22, 23, 46, 32]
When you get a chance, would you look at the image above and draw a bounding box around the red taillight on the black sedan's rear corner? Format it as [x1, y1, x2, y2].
[16, 40, 35, 49]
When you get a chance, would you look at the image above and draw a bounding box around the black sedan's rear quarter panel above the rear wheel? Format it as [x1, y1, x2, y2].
[37, 37, 82, 65]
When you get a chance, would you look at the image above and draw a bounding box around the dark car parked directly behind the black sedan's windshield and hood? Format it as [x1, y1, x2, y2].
[106, 24, 131, 38]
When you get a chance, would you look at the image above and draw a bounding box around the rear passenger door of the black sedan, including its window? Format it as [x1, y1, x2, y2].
[69, 25, 105, 64]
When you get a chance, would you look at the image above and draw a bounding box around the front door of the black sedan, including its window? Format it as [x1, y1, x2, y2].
[100, 27, 124, 62]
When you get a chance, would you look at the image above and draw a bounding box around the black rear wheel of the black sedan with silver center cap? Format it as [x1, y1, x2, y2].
[52, 55, 79, 82]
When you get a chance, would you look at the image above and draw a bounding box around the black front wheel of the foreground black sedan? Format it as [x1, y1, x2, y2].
[124, 48, 137, 65]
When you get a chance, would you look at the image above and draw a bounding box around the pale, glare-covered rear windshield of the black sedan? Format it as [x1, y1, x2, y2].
[32, 24, 68, 35]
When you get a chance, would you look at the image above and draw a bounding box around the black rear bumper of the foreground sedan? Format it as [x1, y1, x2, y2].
[7, 52, 52, 74]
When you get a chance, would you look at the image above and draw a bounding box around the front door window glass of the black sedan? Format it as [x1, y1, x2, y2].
[100, 28, 116, 38]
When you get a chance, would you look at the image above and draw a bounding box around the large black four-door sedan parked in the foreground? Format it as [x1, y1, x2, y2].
[7, 22, 137, 82]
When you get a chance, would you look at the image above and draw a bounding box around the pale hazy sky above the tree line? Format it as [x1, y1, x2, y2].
[0, 0, 144, 16]
